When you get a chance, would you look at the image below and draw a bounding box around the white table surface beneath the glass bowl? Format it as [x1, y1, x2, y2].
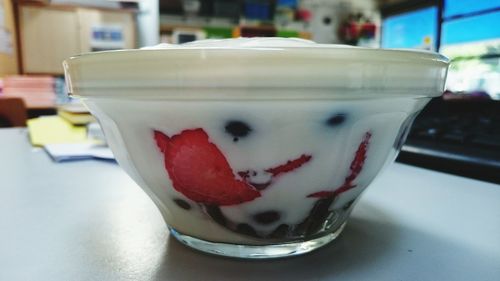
[0, 129, 500, 281]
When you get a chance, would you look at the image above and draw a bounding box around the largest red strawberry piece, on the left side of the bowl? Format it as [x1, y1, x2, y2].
[154, 129, 260, 206]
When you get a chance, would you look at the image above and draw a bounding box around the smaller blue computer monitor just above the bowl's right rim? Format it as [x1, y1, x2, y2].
[382, 6, 438, 51]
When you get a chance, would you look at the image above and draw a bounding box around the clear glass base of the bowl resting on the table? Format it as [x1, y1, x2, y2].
[169, 222, 345, 259]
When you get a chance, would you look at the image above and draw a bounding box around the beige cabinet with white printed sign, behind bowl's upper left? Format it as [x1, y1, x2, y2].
[19, 5, 135, 75]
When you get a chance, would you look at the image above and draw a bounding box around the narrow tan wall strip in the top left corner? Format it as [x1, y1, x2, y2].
[0, 0, 18, 77]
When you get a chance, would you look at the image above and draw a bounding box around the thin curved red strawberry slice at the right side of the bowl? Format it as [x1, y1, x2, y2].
[307, 132, 372, 198]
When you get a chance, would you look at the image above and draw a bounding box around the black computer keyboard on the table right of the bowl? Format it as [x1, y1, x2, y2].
[398, 98, 500, 183]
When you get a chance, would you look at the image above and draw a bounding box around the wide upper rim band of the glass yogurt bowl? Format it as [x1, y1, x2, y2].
[63, 44, 449, 98]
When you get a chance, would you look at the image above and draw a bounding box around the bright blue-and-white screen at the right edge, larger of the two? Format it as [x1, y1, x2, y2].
[439, 0, 500, 100]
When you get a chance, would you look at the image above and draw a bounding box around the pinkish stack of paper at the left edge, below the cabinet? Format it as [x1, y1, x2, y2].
[3, 76, 56, 108]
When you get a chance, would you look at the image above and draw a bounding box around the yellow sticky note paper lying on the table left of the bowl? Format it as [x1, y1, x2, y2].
[28, 116, 90, 146]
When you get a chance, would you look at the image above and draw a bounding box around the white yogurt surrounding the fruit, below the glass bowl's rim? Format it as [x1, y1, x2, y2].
[86, 94, 425, 244]
